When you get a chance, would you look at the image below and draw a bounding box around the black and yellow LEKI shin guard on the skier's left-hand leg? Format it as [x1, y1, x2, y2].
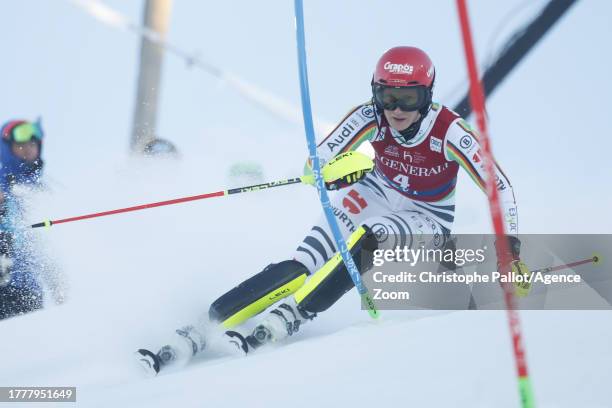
[208, 260, 309, 328]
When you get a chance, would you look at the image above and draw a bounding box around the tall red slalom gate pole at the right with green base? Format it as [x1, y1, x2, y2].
[456, 0, 535, 408]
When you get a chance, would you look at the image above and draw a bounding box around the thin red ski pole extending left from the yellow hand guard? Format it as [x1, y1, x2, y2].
[31, 177, 308, 228]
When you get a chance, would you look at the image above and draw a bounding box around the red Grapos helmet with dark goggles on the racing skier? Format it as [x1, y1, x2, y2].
[372, 47, 436, 114]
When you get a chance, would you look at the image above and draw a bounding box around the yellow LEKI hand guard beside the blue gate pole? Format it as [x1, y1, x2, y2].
[302, 151, 374, 190]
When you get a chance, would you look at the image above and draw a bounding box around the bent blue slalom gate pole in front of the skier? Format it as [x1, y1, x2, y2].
[294, 0, 379, 319]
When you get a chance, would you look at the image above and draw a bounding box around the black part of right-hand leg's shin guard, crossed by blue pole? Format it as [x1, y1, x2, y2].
[296, 227, 378, 313]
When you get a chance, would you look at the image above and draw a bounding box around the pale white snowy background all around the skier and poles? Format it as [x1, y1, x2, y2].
[0, 0, 612, 407]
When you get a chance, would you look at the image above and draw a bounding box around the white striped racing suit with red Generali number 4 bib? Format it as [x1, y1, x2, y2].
[293, 103, 518, 273]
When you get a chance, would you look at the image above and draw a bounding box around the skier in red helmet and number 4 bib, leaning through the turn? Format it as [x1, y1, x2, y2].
[137, 47, 529, 373]
